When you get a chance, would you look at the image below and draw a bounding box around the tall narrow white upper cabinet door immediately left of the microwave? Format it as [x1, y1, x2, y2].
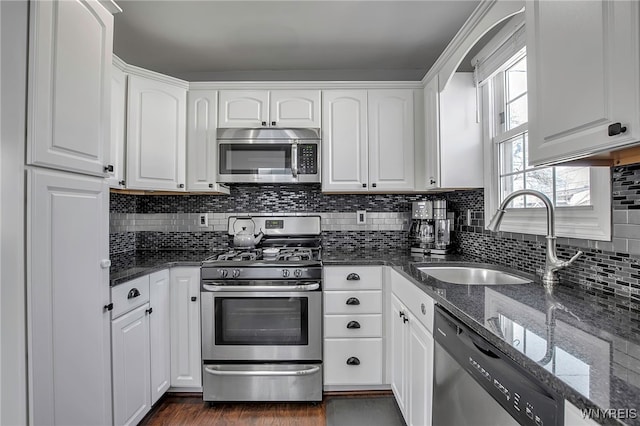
[187, 90, 229, 194]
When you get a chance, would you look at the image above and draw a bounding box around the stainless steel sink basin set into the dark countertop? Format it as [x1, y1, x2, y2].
[416, 265, 532, 285]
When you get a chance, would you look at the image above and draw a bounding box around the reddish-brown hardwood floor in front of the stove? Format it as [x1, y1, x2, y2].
[140, 392, 398, 426]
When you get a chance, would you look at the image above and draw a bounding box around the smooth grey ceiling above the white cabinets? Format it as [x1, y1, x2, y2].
[114, 0, 479, 81]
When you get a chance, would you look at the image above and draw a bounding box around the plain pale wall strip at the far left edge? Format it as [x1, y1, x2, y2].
[0, 0, 28, 425]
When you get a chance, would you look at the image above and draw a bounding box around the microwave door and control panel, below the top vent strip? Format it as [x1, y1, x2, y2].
[218, 139, 320, 183]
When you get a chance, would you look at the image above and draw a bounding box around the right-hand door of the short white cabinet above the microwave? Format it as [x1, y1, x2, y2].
[269, 90, 320, 128]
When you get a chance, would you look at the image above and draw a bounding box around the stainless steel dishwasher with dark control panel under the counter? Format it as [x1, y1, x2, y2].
[433, 306, 564, 426]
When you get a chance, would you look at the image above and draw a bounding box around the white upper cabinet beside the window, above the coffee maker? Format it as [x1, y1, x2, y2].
[416, 73, 483, 189]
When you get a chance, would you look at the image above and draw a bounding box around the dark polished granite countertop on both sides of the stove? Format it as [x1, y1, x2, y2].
[110, 249, 640, 425]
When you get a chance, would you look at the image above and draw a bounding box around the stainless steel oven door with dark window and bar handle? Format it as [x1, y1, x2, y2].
[201, 290, 322, 362]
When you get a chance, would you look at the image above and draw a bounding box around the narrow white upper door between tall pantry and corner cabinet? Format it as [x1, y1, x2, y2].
[107, 63, 127, 188]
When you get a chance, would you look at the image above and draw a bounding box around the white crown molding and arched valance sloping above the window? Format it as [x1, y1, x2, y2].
[422, 0, 524, 92]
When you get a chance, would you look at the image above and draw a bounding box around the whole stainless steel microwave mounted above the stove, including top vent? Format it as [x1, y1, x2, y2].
[216, 128, 321, 183]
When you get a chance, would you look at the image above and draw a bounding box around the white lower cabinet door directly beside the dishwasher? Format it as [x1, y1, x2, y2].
[407, 315, 433, 426]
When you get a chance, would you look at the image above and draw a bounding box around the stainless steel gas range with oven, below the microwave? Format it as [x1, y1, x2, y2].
[201, 216, 322, 401]
